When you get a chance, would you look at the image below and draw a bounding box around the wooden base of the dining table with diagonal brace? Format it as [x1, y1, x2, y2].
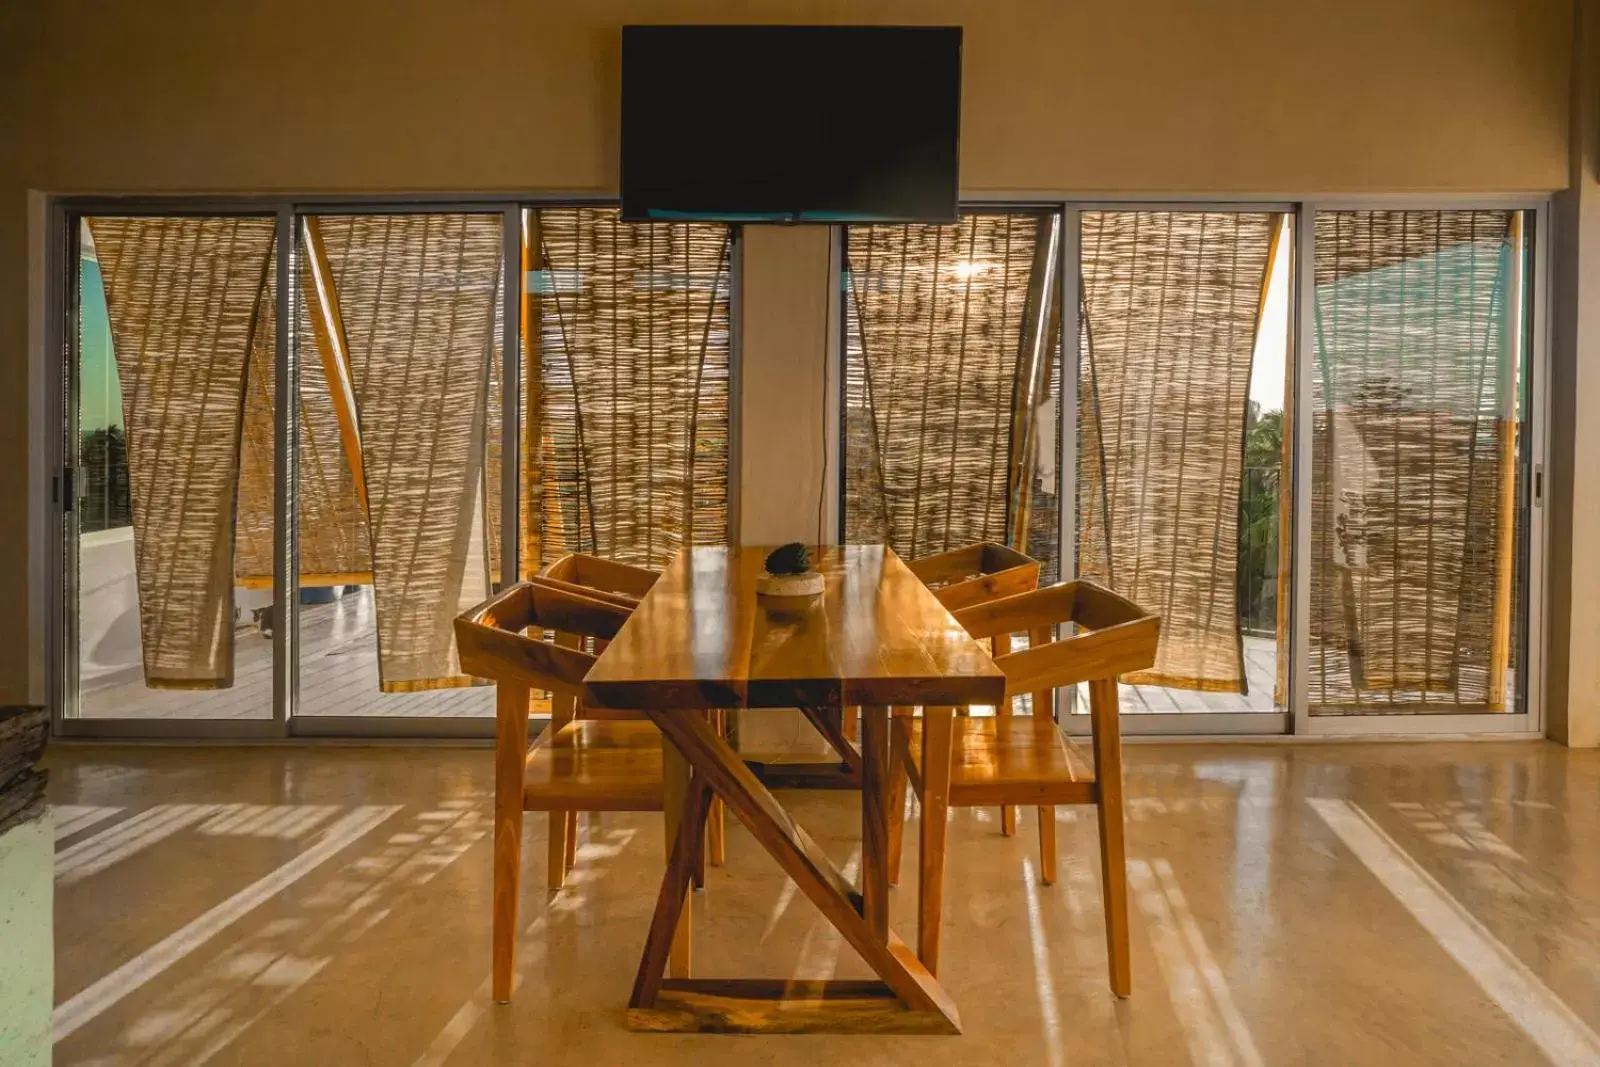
[627, 707, 960, 1033]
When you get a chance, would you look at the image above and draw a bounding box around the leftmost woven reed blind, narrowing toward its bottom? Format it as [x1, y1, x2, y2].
[88, 218, 275, 688]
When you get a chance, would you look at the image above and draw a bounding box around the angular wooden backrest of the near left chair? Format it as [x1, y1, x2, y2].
[456, 582, 629, 697]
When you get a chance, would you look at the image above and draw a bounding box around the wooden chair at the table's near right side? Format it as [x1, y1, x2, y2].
[890, 581, 1160, 997]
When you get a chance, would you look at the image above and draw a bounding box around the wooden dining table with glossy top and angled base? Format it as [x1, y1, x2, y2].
[584, 545, 1005, 1033]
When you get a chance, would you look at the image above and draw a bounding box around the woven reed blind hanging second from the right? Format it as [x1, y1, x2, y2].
[1078, 211, 1277, 693]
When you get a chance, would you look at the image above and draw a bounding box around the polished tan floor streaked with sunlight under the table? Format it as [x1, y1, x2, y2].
[51, 742, 1600, 1067]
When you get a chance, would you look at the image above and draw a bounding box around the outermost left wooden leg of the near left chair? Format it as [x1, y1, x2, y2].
[491, 681, 528, 1005]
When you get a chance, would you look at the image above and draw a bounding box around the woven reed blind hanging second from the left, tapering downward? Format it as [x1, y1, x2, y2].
[316, 214, 501, 693]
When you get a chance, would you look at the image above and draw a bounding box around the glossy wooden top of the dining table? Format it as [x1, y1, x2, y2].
[584, 545, 1005, 710]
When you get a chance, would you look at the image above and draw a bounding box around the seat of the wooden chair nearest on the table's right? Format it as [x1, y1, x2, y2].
[901, 715, 1098, 808]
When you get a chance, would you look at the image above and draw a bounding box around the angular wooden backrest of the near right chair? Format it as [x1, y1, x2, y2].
[955, 581, 1162, 699]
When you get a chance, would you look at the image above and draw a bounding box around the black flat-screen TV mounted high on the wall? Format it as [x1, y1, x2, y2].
[622, 26, 962, 222]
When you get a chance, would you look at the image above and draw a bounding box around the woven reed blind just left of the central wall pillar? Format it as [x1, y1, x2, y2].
[522, 208, 731, 573]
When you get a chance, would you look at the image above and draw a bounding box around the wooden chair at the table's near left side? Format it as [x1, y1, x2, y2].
[456, 581, 726, 1003]
